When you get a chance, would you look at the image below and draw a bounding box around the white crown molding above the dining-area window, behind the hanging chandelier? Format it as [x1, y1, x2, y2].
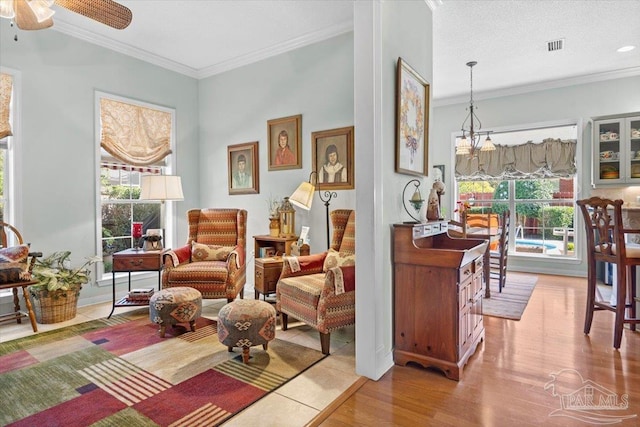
[432, 67, 640, 107]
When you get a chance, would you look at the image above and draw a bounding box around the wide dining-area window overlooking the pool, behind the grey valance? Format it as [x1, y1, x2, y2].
[456, 124, 578, 258]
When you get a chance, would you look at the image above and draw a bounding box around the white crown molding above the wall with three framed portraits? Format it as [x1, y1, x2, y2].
[197, 20, 353, 79]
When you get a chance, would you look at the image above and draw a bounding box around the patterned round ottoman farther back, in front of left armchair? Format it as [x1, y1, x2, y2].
[149, 286, 202, 338]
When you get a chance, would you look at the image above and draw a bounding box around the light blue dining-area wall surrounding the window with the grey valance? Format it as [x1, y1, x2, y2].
[431, 76, 640, 276]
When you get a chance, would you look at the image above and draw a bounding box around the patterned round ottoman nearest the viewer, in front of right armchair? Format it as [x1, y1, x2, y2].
[218, 299, 276, 363]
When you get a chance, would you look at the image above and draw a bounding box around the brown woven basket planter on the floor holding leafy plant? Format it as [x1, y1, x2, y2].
[29, 285, 82, 324]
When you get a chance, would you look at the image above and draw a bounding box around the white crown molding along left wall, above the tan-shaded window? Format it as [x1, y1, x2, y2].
[51, 19, 197, 78]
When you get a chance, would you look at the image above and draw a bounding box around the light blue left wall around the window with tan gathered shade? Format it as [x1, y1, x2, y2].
[0, 19, 200, 305]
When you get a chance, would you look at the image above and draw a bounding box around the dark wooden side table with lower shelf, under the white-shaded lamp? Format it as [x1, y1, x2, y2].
[107, 249, 162, 319]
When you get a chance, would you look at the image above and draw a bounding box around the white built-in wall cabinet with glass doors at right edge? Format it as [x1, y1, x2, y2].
[593, 113, 640, 186]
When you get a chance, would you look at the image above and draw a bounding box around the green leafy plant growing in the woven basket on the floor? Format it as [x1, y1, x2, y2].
[31, 251, 100, 292]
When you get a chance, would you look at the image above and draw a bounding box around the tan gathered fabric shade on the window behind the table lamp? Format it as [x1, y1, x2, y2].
[100, 98, 171, 166]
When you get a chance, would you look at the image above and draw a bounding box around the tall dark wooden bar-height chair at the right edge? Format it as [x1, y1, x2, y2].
[576, 197, 640, 349]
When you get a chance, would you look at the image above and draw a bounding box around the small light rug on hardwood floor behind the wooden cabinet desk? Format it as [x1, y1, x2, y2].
[482, 272, 538, 320]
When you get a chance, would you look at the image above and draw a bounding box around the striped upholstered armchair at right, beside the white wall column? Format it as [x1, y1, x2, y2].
[276, 209, 356, 354]
